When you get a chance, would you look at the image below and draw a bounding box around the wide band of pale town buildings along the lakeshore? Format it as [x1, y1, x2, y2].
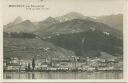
[3, 52, 123, 71]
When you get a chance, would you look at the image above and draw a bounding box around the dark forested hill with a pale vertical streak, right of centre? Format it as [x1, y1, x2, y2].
[44, 29, 123, 57]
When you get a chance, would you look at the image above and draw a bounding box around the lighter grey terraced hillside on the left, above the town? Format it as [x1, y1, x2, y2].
[3, 37, 75, 59]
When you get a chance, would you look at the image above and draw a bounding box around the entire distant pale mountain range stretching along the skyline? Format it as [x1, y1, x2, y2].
[4, 12, 123, 34]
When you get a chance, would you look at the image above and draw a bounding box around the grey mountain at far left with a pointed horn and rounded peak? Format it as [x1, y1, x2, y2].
[4, 18, 36, 33]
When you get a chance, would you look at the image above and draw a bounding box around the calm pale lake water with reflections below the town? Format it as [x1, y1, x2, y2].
[3, 71, 123, 79]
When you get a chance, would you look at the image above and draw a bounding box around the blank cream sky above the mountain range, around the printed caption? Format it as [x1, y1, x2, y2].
[2, 0, 125, 24]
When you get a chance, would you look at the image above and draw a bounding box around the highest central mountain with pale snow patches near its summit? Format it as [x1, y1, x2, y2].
[35, 12, 93, 35]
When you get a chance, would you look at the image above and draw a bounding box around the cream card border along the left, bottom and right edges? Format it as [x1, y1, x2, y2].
[0, 0, 128, 83]
